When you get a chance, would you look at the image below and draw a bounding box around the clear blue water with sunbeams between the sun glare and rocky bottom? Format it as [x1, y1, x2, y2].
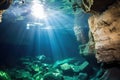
[0, 0, 82, 63]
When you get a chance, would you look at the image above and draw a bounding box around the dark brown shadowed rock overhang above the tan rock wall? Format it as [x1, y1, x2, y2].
[81, 0, 116, 13]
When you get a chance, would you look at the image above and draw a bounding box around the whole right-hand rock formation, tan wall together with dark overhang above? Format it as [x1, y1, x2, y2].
[74, 0, 120, 63]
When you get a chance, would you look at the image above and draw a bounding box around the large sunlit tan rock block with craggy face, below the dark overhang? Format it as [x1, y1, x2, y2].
[89, 1, 120, 62]
